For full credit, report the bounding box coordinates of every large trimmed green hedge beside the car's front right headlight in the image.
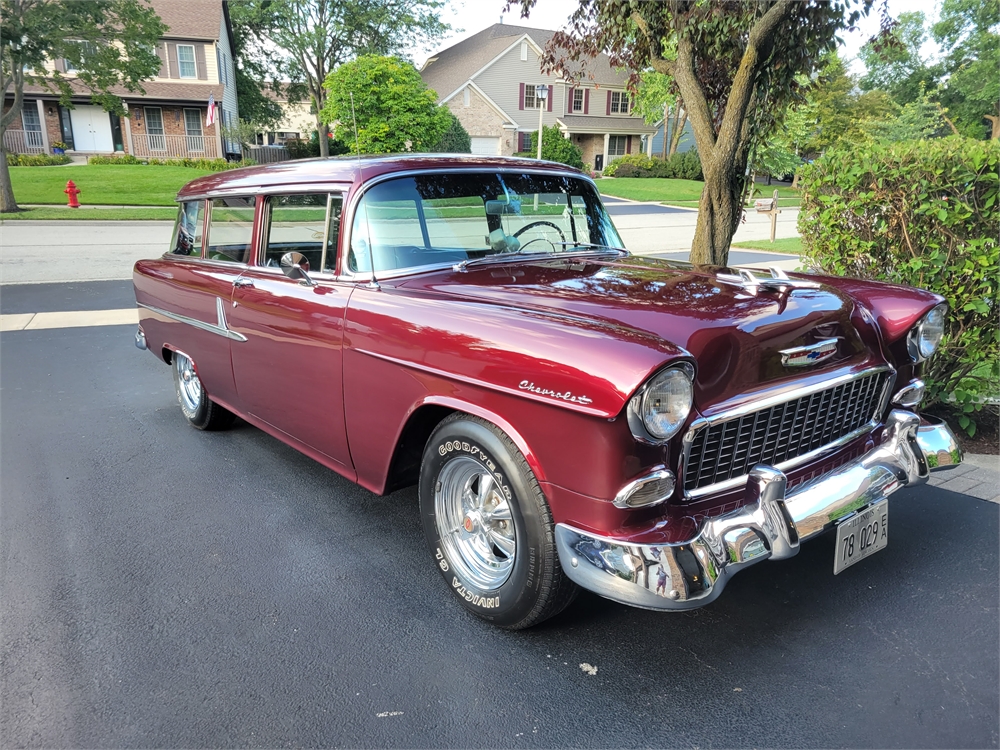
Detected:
[799,136,1000,435]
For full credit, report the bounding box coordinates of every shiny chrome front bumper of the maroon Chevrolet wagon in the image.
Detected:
[556,410,962,610]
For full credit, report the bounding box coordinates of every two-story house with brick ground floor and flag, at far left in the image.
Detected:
[4,0,240,159]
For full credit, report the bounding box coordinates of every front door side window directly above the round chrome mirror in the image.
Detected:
[263,193,344,273]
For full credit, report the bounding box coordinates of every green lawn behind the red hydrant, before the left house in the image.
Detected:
[10,164,211,207]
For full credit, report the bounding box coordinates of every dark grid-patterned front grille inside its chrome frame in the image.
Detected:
[684,371,891,492]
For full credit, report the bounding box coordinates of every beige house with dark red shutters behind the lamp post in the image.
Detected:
[420,23,655,170]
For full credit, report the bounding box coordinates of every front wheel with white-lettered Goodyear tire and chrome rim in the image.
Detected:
[420,414,577,630]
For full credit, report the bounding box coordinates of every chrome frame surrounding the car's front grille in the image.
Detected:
[677,365,896,500]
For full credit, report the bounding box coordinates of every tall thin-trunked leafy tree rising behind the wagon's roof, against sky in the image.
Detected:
[245,0,450,156]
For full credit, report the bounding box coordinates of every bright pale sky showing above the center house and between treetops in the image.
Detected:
[410,0,940,75]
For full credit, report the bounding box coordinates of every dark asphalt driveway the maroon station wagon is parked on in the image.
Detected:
[0,280,1000,748]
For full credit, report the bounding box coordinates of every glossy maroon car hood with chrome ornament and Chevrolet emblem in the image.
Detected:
[405,257,879,407]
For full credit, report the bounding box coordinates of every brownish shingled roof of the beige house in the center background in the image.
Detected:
[420,23,628,101]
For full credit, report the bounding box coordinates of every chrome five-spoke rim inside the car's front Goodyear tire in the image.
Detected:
[434,456,517,591]
